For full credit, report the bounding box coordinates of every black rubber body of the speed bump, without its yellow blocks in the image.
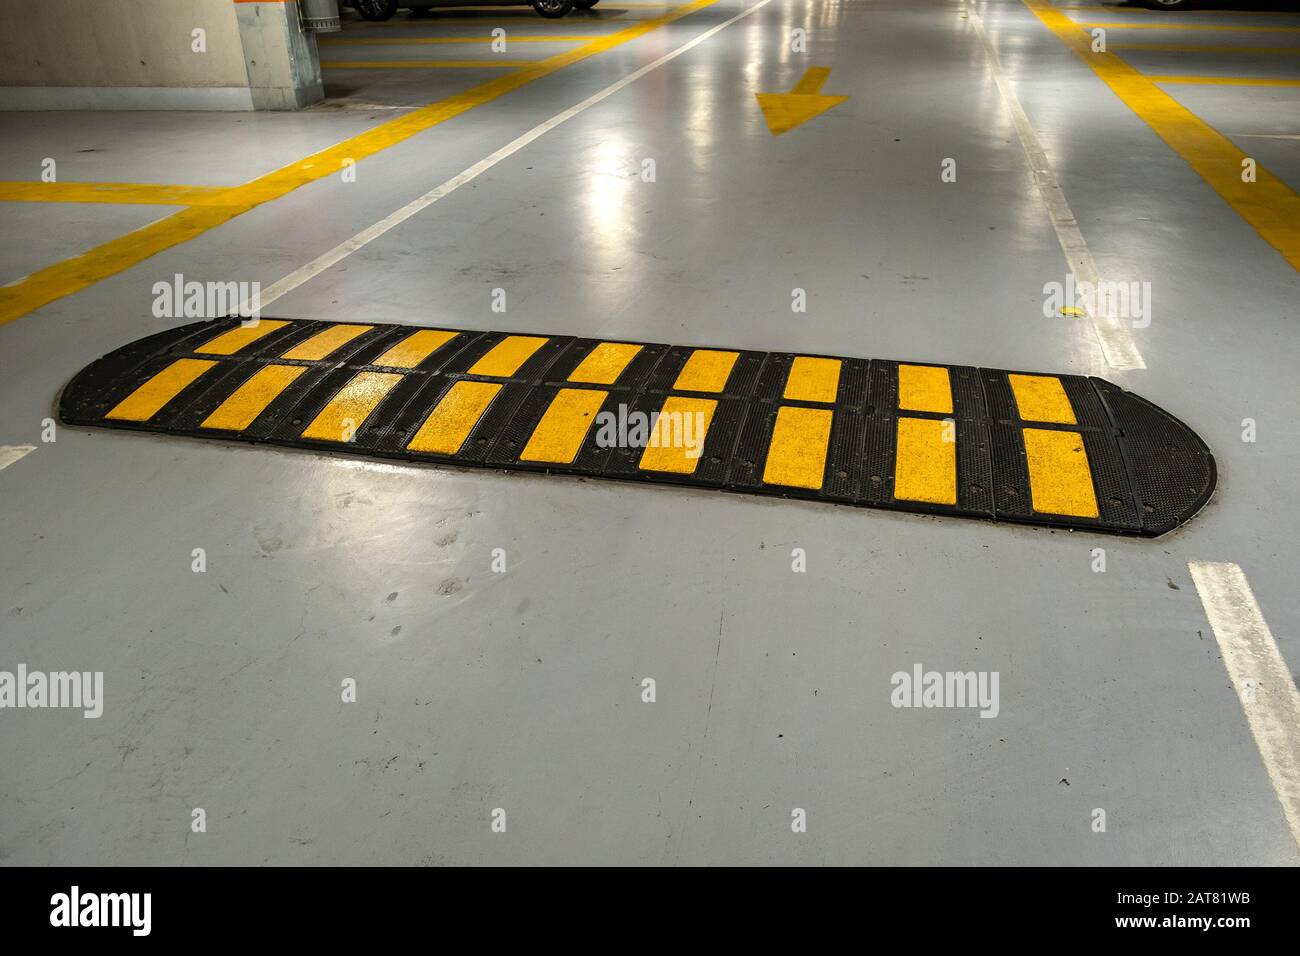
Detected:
[59,319,1216,537]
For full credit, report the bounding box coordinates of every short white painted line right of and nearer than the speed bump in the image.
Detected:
[1187,561,1300,848]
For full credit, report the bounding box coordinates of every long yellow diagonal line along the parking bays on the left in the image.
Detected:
[0,0,718,325]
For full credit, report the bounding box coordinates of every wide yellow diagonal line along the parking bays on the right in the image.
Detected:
[1023,0,1300,269]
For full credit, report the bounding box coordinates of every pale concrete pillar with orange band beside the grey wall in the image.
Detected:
[235,0,325,109]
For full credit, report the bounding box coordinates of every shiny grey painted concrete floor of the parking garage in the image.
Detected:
[0,0,1300,865]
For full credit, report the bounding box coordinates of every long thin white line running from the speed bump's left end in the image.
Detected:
[253,0,772,308]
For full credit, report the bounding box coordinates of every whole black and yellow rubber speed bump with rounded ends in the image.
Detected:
[60,319,1216,537]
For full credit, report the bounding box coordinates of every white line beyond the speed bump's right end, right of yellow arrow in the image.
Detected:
[962,7,1147,372]
